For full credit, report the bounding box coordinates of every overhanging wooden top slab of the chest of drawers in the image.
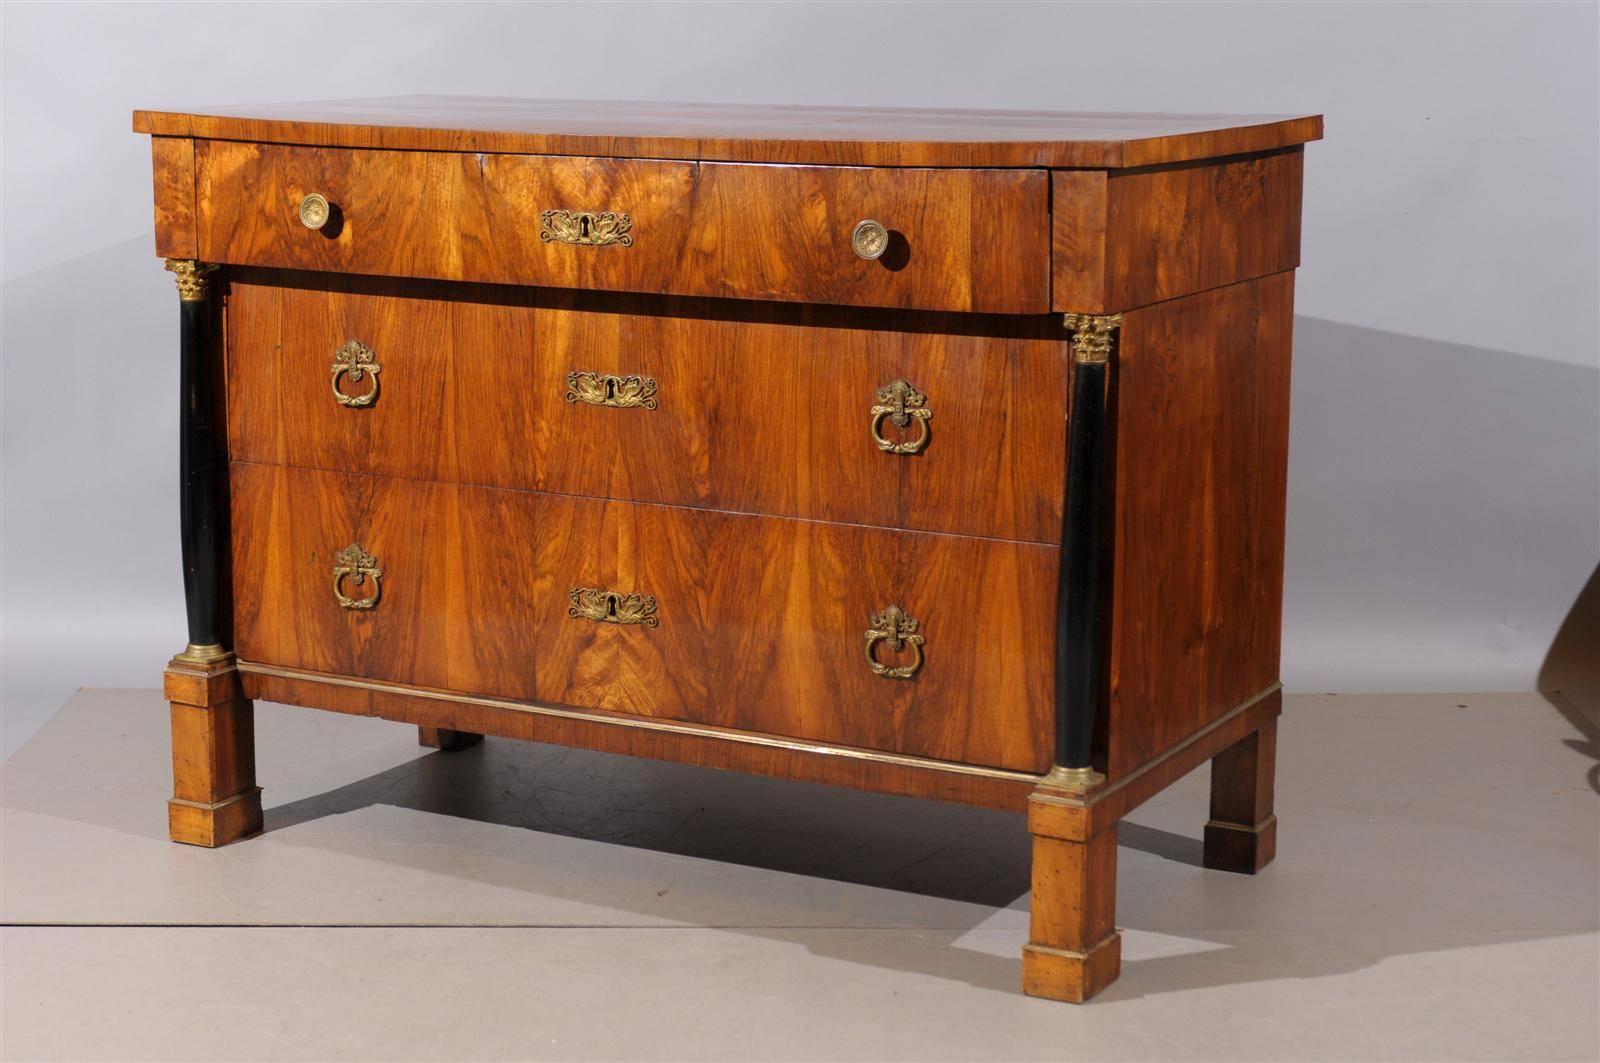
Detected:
[133,96,1322,168]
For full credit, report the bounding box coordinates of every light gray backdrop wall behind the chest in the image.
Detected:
[0,3,1600,752]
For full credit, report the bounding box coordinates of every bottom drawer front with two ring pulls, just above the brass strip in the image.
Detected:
[232,464,1056,772]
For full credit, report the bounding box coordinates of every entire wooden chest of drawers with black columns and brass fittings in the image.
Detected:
[134,98,1320,1001]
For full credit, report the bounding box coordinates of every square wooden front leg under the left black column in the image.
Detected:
[163,653,261,848]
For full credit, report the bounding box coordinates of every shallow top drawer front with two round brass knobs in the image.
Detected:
[195,141,1050,314]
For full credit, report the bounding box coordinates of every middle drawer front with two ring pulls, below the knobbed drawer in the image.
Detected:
[229,279,1067,543]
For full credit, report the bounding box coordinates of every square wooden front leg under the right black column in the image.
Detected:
[1022,789,1122,1004]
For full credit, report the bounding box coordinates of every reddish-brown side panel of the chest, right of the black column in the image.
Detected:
[1099,274,1294,780]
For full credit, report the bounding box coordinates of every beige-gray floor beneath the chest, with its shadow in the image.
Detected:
[0,690,1600,1061]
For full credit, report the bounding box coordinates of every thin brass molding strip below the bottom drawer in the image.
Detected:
[238,661,1043,786]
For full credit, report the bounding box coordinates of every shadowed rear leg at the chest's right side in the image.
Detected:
[1205,717,1278,874]
